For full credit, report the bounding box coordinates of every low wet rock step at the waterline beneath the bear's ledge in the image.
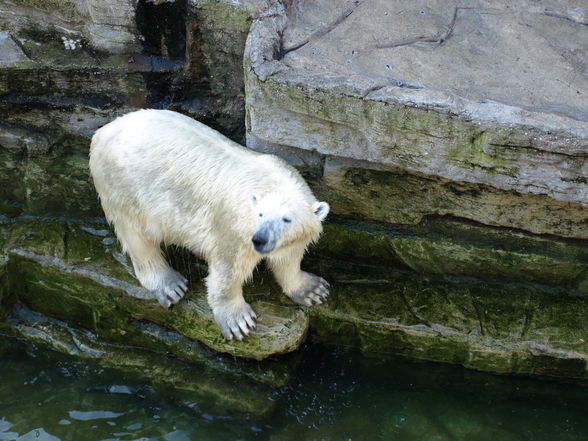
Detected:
[8,306,276,417]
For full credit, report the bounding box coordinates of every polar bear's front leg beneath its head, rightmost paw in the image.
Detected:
[268,247,329,306]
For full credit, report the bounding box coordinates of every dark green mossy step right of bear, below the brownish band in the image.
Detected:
[312,218,588,294]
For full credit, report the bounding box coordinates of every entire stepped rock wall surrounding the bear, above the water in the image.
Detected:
[0,0,588,374]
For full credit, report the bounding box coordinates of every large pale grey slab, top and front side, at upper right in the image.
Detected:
[245,0,588,206]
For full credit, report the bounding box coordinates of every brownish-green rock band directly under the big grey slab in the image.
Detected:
[313,162,588,239]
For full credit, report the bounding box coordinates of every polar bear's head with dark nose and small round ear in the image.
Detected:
[251,193,329,255]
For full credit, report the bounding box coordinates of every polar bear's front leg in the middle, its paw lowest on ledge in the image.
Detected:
[206,259,257,340]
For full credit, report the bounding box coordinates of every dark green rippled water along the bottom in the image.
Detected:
[0,338,588,441]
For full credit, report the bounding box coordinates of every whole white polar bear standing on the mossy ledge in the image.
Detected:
[90,110,329,340]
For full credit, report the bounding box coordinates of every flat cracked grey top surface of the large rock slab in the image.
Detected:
[282,0,588,122]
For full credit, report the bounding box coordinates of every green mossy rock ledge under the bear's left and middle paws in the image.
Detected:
[4,222,308,360]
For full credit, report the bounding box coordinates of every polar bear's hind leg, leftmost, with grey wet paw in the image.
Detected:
[114,221,187,308]
